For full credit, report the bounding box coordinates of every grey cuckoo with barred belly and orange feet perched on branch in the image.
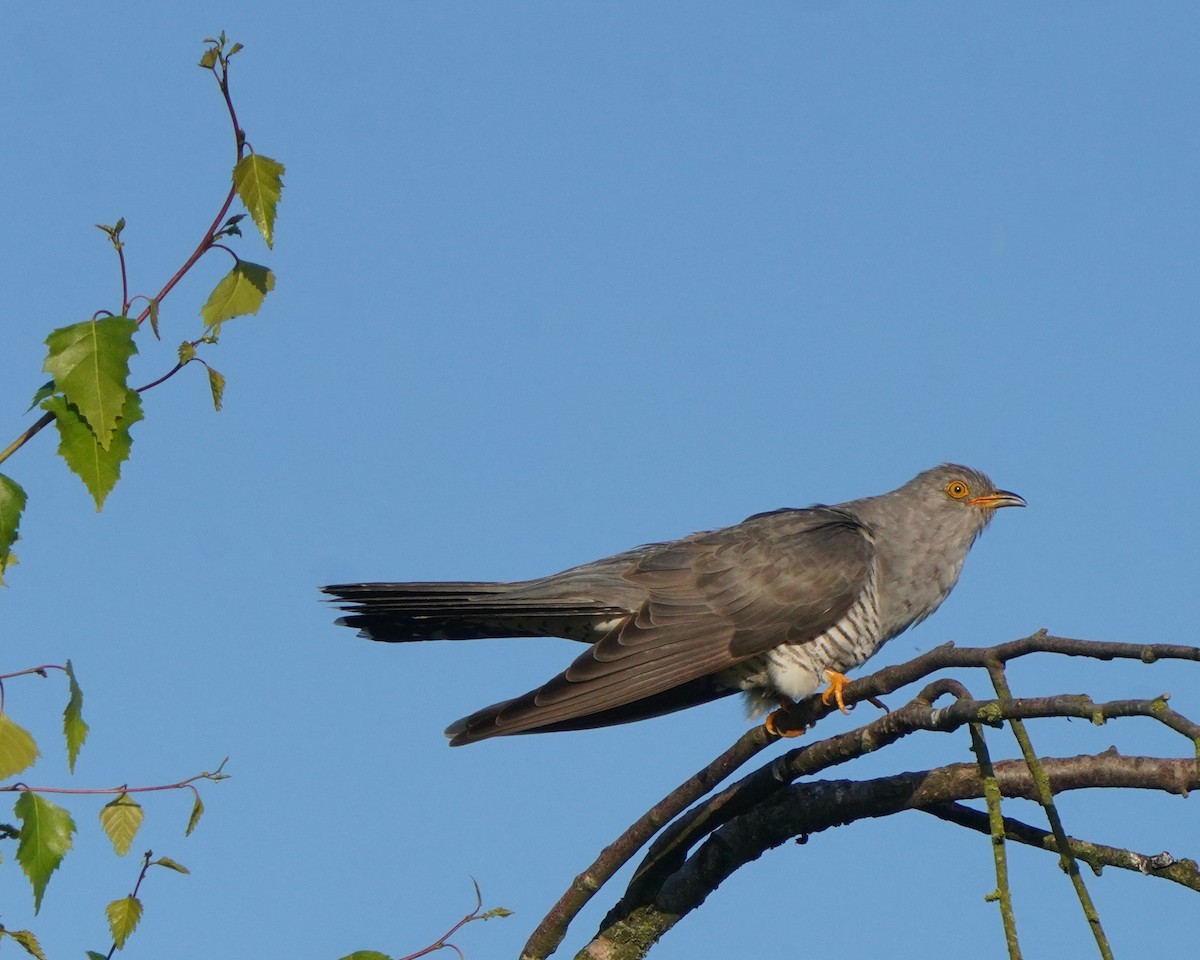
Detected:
[322,463,1026,746]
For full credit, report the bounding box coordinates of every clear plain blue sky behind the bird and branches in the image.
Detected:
[0,1,1200,959]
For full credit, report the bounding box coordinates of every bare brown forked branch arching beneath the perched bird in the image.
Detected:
[522,631,1200,960]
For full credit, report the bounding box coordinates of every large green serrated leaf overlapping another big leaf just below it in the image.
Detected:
[43,317,138,450]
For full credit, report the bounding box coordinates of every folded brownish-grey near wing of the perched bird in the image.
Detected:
[448,508,874,743]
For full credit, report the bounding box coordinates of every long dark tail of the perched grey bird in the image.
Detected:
[322,582,628,643]
